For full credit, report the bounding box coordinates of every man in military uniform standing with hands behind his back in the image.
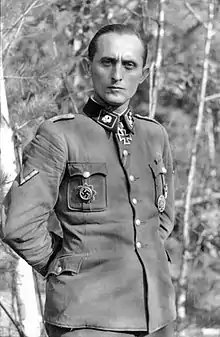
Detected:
[2,24,175,337]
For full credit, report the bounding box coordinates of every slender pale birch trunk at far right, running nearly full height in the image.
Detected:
[177,0,215,326]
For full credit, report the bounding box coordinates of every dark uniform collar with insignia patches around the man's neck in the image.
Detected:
[83,98,134,133]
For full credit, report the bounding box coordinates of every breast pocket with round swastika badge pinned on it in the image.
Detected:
[67,162,107,212]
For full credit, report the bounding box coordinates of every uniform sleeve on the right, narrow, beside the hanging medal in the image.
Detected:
[160,127,175,242]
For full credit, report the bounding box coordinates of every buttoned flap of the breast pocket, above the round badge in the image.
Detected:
[67,162,107,178]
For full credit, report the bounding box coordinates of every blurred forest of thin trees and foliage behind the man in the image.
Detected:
[0,0,220,337]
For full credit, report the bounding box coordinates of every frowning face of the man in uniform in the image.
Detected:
[90,33,145,110]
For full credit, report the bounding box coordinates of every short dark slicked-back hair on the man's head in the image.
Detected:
[88,23,148,65]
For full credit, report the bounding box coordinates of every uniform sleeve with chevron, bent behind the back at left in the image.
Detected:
[1,121,66,275]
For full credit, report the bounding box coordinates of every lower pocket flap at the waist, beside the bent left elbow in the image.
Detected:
[46,255,84,277]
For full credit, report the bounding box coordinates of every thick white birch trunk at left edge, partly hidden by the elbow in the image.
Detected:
[0,44,41,337]
